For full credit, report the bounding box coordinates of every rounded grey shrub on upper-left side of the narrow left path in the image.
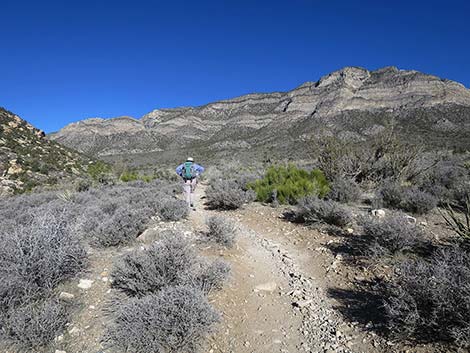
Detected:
[91,206,152,247]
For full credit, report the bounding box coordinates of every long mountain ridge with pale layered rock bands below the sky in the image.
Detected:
[51,67,470,163]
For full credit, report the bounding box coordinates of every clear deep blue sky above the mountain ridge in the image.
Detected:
[0,0,470,132]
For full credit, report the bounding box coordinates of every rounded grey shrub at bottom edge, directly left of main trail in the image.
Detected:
[105,286,219,353]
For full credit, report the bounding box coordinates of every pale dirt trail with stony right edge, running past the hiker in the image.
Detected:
[190,186,383,353]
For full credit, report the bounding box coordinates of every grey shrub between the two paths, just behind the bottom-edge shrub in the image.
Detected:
[112,233,197,296]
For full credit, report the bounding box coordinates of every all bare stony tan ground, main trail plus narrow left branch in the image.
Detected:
[35,185,454,353]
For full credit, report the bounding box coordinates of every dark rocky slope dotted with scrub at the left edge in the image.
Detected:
[0,108,89,195]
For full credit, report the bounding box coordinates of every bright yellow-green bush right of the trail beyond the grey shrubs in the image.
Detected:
[248,165,330,204]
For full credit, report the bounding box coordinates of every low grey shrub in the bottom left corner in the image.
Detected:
[0,298,69,351]
